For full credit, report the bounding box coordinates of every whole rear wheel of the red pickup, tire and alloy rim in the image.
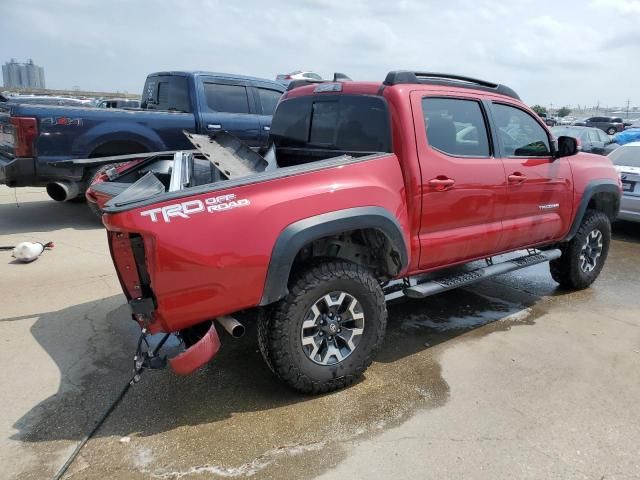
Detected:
[258,261,387,393]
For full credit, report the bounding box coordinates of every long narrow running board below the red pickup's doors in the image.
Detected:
[402,249,562,298]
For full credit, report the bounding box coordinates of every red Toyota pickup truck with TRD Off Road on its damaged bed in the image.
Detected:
[90,71,621,392]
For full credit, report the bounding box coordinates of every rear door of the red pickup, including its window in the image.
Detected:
[411,92,506,270]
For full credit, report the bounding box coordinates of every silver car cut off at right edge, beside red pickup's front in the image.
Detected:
[609,142,640,222]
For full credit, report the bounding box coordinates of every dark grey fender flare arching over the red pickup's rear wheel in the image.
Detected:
[260,207,409,305]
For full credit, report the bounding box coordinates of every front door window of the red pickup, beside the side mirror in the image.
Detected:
[493,103,551,157]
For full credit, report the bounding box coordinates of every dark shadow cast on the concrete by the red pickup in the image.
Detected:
[11,270,559,443]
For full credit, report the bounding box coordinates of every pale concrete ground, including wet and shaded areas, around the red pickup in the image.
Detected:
[0,187,640,479]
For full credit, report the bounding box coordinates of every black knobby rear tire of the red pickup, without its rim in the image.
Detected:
[258,260,387,393]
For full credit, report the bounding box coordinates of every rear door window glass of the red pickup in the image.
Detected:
[422,97,490,157]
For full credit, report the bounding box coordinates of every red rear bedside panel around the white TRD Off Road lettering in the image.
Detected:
[103,154,409,331]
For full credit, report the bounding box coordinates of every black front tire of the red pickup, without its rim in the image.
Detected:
[549,210,611,290]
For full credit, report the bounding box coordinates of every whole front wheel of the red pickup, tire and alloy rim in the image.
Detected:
[549,210,611,290]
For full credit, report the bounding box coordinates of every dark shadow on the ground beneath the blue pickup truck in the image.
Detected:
[0,195,103,234]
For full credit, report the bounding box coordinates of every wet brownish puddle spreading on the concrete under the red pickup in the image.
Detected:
[15,280,538,479]
